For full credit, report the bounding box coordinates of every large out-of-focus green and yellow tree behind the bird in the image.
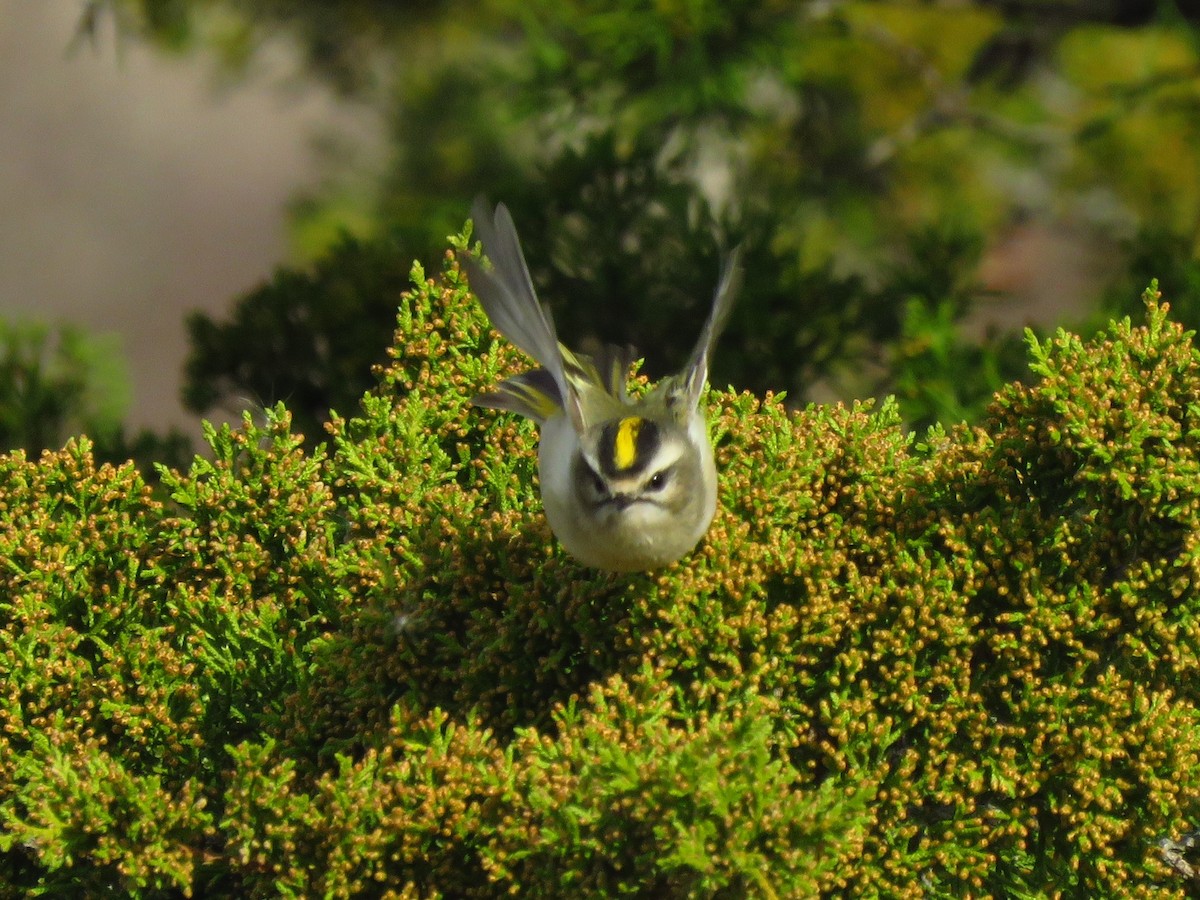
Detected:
[84,0,1200,439]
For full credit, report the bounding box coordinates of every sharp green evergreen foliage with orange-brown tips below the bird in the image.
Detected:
[0,239,1200,898]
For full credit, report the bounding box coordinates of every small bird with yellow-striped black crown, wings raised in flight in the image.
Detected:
[462,199,740,571]
